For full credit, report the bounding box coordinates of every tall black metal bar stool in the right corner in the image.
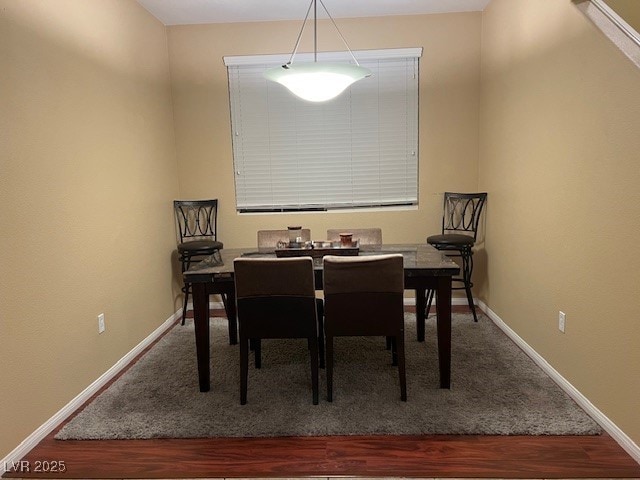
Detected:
[425,192,487,322]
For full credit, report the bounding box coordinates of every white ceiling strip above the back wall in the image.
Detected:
[137,0,491,25]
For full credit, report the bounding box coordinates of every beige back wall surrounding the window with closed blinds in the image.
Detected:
[168,12,481,247]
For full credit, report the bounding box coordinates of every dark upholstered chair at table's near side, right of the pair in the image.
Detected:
[324,254,407,402]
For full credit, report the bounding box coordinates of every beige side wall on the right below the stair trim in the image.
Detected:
[479,0,640,443]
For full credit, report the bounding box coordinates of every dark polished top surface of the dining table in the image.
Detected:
[184,243,460,282]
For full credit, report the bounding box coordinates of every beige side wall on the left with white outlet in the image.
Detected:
[0,0,178,457]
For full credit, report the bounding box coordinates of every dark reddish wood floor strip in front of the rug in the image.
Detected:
[3,308,640,479]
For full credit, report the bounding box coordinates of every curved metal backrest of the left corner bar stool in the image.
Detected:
[173,199,218,243]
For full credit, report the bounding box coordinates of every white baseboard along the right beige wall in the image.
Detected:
[478,302,640,463]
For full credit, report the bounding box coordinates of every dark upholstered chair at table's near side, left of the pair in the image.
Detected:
[233,257,322,405]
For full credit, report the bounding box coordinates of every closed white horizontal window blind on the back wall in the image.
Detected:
[225,49,422,212]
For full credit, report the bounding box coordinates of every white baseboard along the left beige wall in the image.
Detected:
[0,309,182,468]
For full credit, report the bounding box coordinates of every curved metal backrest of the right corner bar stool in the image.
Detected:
[442,192,487,241]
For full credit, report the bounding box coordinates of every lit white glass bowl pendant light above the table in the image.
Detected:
[264,0,371,102]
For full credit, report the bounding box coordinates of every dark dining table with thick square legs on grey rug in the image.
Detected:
[183,244,460,392]
